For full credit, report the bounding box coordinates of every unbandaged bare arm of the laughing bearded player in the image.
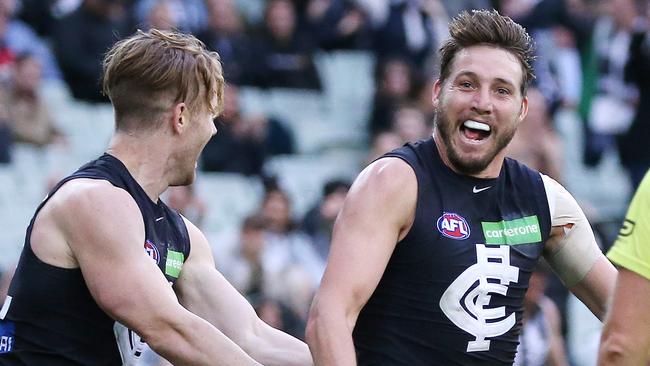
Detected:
[307,158,417,366]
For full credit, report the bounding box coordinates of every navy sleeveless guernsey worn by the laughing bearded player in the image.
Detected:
[353,138,551,366]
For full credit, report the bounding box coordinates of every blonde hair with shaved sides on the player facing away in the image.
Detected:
[103,29,225,130]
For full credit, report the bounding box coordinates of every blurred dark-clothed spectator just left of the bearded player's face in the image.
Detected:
[368,57,414,136]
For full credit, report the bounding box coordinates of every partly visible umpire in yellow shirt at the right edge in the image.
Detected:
[598,172,650,366]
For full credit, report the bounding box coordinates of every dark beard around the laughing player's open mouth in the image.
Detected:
[434,110,516,175]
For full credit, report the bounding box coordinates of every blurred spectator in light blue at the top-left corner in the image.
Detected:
[0,0,61,79]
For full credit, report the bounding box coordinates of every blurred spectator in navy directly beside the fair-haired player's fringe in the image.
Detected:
[199,0,258,85]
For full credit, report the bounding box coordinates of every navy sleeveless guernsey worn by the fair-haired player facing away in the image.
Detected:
[0,154,190,366]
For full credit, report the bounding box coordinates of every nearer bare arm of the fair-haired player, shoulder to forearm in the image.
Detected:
[53,180,258,365]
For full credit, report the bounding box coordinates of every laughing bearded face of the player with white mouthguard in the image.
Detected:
[433,45,528,178]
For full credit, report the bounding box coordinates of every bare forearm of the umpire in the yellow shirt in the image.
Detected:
[598,268,650,366]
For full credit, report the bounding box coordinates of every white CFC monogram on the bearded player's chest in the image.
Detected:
[440,244,519,352]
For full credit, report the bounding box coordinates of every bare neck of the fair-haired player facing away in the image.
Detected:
[106,132,170,202]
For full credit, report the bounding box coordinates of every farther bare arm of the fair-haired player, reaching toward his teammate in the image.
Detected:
[175,220,313,366]
